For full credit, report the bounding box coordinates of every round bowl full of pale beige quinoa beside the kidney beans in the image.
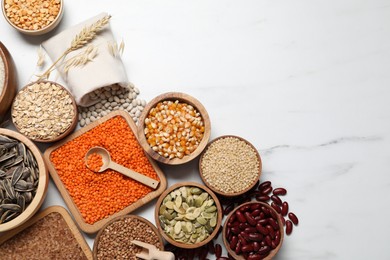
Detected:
[199,135,262,197]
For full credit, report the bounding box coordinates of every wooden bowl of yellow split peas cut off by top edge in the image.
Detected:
[2,0,64,35]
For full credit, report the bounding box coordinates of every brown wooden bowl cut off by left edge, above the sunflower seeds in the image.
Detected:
[0,42,17,121]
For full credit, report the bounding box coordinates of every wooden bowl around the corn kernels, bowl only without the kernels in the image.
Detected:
[138,92,211,165]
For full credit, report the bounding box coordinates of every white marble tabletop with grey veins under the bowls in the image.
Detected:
[0,0,390,260]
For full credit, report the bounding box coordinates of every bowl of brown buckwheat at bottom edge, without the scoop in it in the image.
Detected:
[93,215,164,260]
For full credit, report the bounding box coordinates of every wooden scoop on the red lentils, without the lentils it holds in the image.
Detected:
[85,146,159,189]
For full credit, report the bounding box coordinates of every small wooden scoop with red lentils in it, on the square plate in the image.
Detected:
[85,146,159,189]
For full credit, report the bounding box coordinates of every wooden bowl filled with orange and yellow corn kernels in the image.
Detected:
[138,92,211,165]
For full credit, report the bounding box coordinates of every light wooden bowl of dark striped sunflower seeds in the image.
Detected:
[0,128,49,232]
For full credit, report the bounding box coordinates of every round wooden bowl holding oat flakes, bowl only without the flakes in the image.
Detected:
[11,80,78,143]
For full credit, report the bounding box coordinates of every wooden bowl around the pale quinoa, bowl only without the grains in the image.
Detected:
[199,135,262,197]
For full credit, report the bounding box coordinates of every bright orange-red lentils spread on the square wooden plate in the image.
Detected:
[50,116,158,224]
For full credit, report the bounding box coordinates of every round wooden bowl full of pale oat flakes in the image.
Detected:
[11,81,77,142]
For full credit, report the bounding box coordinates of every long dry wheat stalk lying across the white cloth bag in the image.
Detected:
[39,15,111,80]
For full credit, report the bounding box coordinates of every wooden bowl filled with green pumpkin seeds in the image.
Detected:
[155,182,222,248]
